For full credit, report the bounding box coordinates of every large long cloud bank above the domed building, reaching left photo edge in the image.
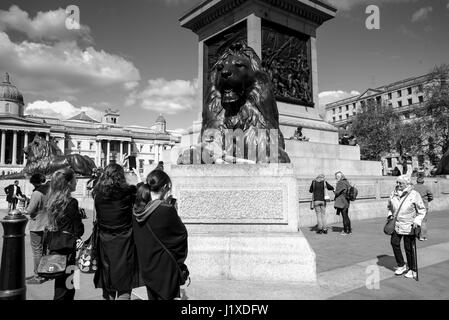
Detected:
[0,32,140,99]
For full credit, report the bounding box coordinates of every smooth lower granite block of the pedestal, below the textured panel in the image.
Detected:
[186,230,316,282]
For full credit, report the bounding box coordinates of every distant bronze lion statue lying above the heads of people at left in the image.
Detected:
[23,136,96,176]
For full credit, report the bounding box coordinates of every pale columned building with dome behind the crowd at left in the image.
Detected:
[0,73,180,175]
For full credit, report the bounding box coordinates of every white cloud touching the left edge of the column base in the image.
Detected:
[126,78,199,114]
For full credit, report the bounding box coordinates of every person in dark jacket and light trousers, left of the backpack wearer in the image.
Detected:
[309,174,334,234]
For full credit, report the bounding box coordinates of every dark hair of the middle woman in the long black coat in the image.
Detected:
[92,163,128,199]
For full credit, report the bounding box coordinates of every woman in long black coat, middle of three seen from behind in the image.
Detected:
[93,163,139,300]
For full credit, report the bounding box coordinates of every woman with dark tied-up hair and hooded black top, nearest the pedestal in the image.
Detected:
[133,170,188,300]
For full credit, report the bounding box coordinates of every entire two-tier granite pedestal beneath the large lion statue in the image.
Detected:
[170,164,316,281]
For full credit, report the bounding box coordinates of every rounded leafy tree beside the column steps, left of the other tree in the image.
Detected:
[351,101,400,160]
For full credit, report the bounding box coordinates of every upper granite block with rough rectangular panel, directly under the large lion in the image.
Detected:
[170,164,299,232]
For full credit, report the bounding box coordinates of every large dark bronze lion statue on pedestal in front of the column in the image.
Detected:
[178,41,290,164]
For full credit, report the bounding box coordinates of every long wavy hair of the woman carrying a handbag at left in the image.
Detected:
[46,168,75,227]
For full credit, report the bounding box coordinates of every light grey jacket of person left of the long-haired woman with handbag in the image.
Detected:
[26,182,50,232]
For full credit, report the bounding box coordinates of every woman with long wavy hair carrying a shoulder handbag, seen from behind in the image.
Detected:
[46,168,84,300]
